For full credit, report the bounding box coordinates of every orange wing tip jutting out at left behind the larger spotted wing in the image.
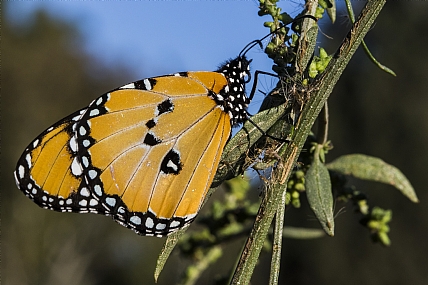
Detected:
[14,109,108,214]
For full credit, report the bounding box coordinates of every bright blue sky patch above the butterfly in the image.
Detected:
[5,0,303,111]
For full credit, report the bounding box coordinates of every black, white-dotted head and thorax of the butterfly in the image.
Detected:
[214,55,251,125]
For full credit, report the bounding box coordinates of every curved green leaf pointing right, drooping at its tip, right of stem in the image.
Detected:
[327,154,419,203]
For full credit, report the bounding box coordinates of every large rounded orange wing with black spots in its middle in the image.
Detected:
[75,72,231,236]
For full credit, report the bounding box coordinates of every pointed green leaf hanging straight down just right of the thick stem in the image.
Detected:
[305,145,334,236]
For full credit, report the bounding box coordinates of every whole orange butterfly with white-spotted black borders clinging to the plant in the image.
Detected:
[14,16,314,236]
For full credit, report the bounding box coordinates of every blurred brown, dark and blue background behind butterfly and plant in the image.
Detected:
[0,0,428,285]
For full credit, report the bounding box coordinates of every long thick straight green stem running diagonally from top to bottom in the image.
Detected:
[231,0,386,285]
